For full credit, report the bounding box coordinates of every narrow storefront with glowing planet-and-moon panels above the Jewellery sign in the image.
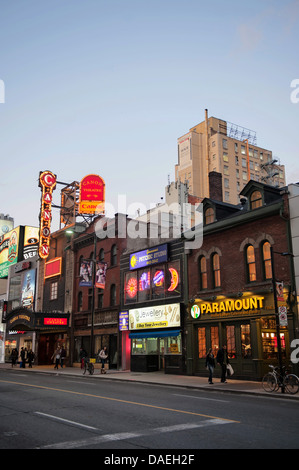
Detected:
[119,240,185,374]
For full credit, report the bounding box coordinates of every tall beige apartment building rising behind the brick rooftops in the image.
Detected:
[175,110,286,204]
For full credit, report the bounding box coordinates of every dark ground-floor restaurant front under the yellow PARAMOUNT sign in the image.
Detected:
[187,292,293,380]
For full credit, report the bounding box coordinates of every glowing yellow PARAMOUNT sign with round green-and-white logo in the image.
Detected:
[190,297,264,318]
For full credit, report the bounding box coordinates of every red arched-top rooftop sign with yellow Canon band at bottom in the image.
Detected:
[79,175,105,215]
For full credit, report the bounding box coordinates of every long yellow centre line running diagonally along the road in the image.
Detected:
[0,380,240,423]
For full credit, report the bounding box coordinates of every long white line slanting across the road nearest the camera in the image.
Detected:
[39,418,232,449]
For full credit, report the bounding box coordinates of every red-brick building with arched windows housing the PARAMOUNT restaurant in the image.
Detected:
[186,175,296,379]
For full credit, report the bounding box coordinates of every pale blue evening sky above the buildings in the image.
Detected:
[0,0,299,230]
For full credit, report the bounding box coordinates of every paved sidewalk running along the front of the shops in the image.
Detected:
[0,364,299,400]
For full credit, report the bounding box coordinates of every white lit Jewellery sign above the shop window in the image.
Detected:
[129,304,181,330]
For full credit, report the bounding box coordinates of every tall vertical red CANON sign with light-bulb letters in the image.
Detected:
[39,171,56,259]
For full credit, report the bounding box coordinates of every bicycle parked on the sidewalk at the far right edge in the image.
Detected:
[262,365,299,395]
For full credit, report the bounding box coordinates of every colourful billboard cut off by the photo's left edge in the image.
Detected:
[0,227,20,278]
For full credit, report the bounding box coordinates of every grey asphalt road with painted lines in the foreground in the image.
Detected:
[0,370,299,454]
